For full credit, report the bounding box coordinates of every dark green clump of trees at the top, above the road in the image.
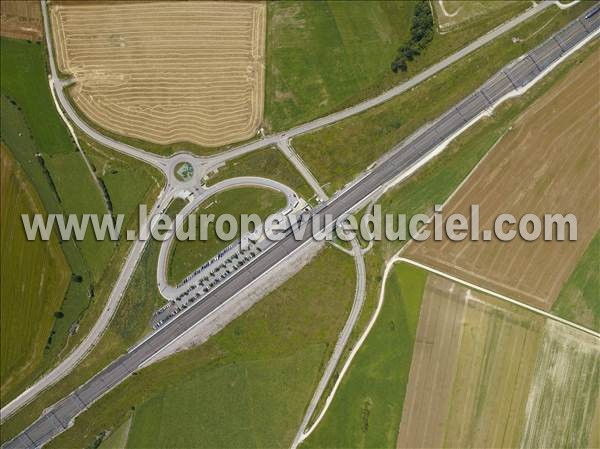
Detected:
[392,0,433,73]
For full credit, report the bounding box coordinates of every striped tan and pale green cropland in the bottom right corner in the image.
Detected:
[398,275,600,448]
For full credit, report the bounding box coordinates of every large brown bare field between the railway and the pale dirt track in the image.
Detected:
[407,48,600,309]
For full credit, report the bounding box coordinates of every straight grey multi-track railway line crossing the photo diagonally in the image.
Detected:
[3,4,600,448]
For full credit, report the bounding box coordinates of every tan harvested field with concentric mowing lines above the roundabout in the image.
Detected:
[51,1,266,147]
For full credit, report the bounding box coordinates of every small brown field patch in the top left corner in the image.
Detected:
[0,0,42,41]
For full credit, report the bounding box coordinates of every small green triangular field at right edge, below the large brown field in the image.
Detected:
[552,232,600,331]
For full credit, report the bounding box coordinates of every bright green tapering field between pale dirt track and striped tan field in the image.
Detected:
[303,264,427,448]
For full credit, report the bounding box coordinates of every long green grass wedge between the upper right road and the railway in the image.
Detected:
[293,5,586,193]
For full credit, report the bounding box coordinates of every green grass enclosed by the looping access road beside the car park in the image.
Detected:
[168,188,286,283]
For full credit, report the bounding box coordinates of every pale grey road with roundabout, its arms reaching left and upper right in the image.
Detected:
[0,0,553,422]
